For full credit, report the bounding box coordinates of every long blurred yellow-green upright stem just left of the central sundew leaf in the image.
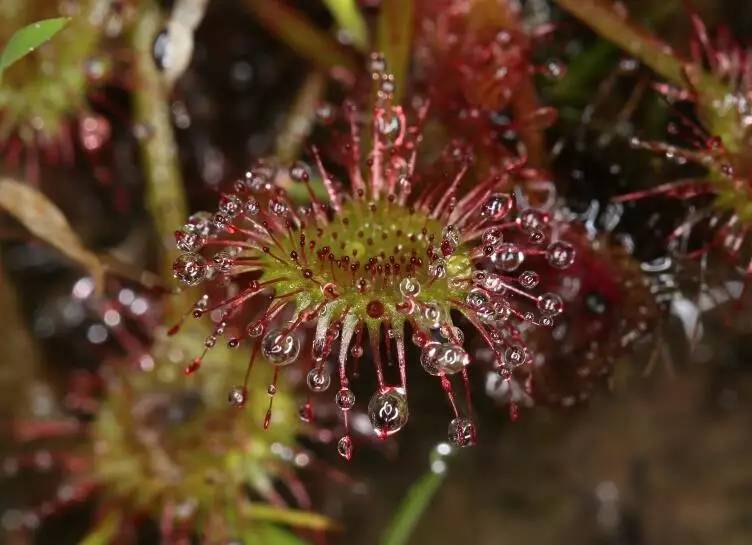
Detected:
[132,4,187,284]
